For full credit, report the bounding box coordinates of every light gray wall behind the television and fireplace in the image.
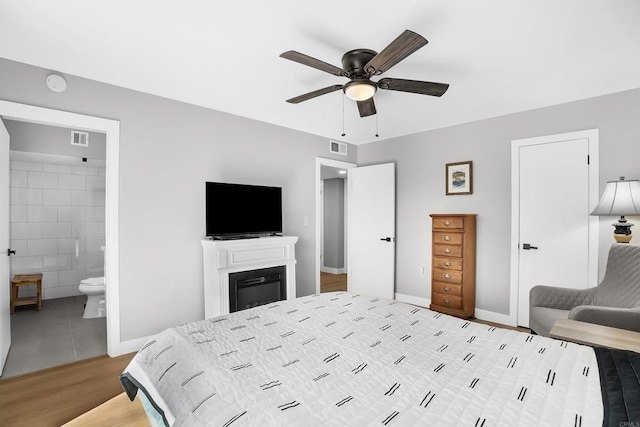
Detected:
[0,59,357,341]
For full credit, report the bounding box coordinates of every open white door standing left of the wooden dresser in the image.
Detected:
[347,163,396,299]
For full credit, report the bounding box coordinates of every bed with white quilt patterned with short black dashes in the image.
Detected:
[121,292,640,427]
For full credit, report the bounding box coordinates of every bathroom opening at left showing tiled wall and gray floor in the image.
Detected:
[2,119,106,378]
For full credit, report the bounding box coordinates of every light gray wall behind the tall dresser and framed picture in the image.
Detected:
[358,89,640,314]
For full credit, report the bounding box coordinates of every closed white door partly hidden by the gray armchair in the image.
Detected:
[513,134,597,327]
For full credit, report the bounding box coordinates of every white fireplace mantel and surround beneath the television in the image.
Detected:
[201,236,298,319]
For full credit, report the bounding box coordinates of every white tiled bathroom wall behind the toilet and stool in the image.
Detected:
[9,151,105,299]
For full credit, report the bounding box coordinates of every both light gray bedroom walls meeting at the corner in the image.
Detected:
[5,55,640,332]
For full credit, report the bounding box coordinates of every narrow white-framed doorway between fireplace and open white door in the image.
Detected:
[315,157,357,293]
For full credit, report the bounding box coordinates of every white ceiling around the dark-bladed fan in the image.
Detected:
[0,0,640,144]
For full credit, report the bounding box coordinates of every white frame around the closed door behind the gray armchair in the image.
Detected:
[509,129,600,326]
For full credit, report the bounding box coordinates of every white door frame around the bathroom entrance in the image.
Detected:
[0,100,122,357]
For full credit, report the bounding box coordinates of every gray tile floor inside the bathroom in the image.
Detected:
[0,295,107,378]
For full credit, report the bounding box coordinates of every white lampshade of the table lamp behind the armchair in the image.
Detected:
[591,177,640,216]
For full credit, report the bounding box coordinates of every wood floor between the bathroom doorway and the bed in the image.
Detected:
[0,353,133,427]
